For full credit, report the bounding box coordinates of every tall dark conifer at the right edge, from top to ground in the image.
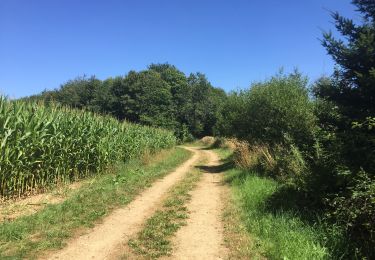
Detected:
[313,0,375,259]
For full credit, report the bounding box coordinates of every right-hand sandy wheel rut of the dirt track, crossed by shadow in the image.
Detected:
[170,151,227,260]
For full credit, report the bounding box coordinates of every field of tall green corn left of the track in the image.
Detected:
[0,97,176,197]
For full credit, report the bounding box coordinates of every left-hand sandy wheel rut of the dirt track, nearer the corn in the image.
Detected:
[48,148,202,259]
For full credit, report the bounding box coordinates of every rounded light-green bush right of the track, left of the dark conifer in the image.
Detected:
[215,73,317,151]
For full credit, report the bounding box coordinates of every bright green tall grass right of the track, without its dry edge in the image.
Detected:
[228,172,330,259]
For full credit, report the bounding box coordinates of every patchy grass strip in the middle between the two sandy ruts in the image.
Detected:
[123,155,206,259]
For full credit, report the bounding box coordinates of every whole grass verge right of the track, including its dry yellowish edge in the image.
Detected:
[215,149,335,259]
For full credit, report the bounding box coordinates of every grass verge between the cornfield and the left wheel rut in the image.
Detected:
[0,148,191,259]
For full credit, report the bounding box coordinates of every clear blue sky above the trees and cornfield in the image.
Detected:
[0,0,359,98]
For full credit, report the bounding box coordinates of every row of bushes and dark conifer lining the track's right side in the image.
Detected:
[216,0,375,259]
